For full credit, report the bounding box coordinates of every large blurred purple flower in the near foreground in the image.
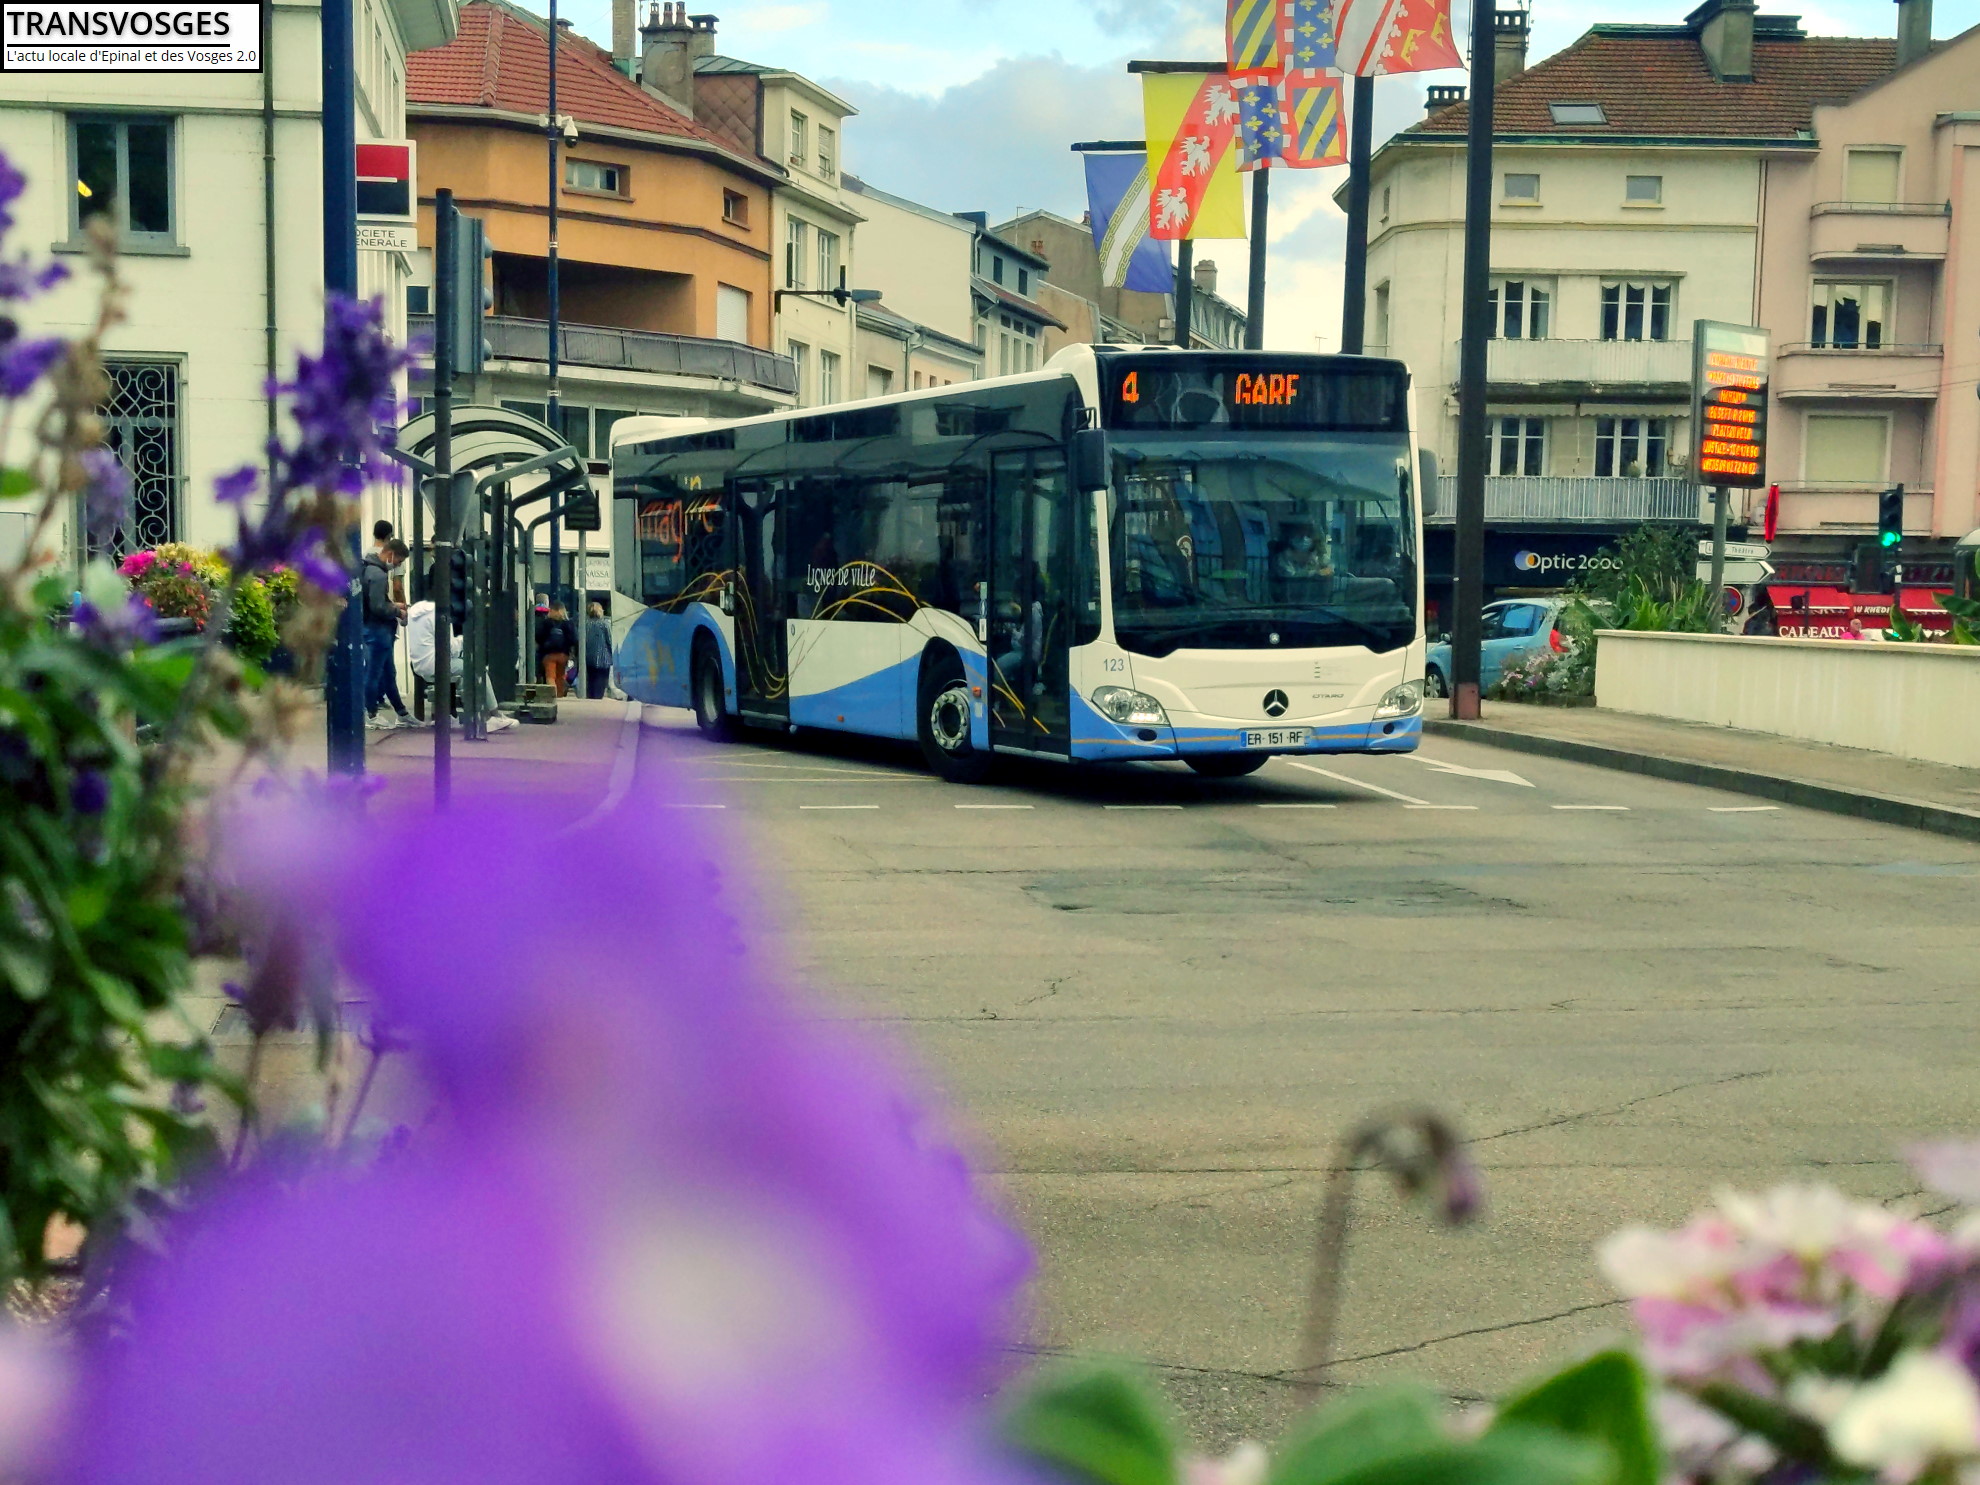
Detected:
[67,768,1026,1485]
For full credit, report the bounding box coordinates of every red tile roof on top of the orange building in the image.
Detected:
[406,0,729,149]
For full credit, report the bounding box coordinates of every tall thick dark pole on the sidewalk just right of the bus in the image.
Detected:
[1451,0,1497,719]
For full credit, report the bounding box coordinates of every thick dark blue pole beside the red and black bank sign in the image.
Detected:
[321,0,366,774]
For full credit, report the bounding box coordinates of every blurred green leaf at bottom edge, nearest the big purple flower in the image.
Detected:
[1002,1366,1176,1485]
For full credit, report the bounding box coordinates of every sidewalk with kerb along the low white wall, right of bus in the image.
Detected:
[1424,701,1980,840]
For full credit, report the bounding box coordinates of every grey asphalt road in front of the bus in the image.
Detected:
[640,709,1980,1443]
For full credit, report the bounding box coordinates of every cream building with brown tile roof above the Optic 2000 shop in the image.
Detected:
[1366,0,1972,605]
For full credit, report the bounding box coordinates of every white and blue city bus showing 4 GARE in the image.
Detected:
[612,347,1424,782]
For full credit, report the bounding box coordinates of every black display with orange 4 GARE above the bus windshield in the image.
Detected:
[1101,356,1408,432]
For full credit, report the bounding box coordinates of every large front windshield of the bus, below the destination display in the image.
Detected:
[1109,430,1416,655]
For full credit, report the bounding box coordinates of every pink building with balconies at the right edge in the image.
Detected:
[1752,0,1980,562]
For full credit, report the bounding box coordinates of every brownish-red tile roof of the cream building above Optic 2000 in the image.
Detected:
[1408,26,1897,139]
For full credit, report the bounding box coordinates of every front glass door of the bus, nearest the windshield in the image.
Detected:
[986,449,1073,752]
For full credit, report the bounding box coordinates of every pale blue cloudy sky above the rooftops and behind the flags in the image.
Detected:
[539,0,1948,350]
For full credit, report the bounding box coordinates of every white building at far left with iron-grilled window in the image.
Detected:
[0,0,455,562]
